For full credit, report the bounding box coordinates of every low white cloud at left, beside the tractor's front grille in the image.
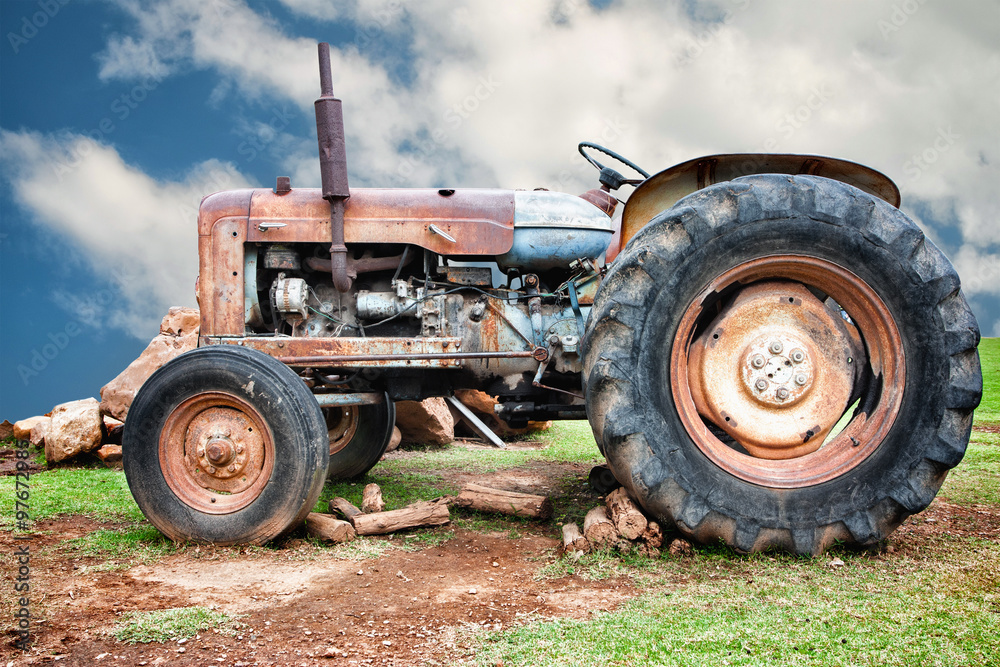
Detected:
[0,130,246,339]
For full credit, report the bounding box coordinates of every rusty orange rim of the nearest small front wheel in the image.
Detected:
[159,392,275,514]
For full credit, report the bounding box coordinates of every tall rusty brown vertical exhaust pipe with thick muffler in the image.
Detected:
[316,42,351,292]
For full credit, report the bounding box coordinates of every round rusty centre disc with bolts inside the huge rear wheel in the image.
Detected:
[690,280,857,459]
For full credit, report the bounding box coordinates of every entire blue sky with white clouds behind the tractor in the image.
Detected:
[0,0,1000,420]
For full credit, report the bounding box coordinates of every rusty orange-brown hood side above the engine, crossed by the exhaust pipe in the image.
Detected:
[248,188,514,255]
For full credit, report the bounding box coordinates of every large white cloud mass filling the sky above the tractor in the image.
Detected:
[76,0,1000,324]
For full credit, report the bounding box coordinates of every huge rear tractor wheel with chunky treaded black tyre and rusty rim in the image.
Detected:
[584,175,982,554]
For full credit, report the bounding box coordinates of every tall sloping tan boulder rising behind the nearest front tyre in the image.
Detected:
[101,307,198,421]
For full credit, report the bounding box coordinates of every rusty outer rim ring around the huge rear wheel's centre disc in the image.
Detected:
[670,255,905,488]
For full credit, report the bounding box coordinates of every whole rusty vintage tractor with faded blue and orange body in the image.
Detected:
[124,44,982,553]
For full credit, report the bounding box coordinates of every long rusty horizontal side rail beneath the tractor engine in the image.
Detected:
[201,336,533,368]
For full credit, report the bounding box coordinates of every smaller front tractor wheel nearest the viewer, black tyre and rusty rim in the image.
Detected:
[122,346,329,544]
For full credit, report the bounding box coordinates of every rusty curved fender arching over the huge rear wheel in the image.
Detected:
[620,153,900,247]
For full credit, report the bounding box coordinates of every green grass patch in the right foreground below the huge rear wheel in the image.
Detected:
[474,543,1000,667]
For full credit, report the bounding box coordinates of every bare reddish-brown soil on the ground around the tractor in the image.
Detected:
[0,440,1000,667]
